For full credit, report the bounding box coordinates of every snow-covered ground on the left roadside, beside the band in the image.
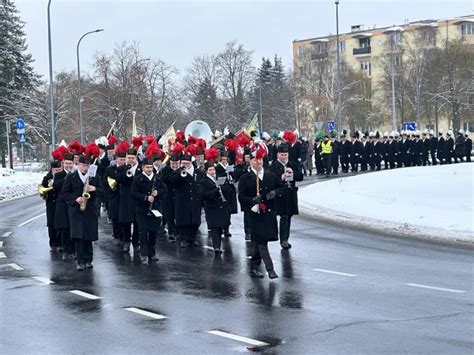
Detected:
[0,163,46,202]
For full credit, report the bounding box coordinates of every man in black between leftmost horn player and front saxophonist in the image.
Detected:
[54,153,74,260]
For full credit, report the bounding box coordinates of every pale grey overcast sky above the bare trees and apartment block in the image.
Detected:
[15,0,474,77]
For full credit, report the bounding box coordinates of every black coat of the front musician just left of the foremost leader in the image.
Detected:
[199,176,230,229]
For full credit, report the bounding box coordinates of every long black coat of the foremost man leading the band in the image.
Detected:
[239,170,284,243]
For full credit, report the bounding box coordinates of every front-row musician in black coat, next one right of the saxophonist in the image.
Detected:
[131,157,167,264]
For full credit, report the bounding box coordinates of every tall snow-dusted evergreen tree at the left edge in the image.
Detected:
[0,0,39,166]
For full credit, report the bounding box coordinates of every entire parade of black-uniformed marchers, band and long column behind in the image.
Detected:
[38,121,472,279]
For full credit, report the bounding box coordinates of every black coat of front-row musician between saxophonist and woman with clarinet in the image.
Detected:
[132,173,167,232]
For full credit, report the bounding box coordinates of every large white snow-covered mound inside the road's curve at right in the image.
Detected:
[299,163,474,243]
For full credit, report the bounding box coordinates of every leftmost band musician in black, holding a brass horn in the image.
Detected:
[41,158,66,253]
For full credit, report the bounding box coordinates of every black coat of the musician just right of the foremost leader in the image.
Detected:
[269,160,303,216]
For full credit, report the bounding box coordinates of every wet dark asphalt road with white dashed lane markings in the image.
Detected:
[0,182,474,354]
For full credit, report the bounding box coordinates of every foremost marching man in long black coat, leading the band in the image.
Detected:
[239,143,283,279]
